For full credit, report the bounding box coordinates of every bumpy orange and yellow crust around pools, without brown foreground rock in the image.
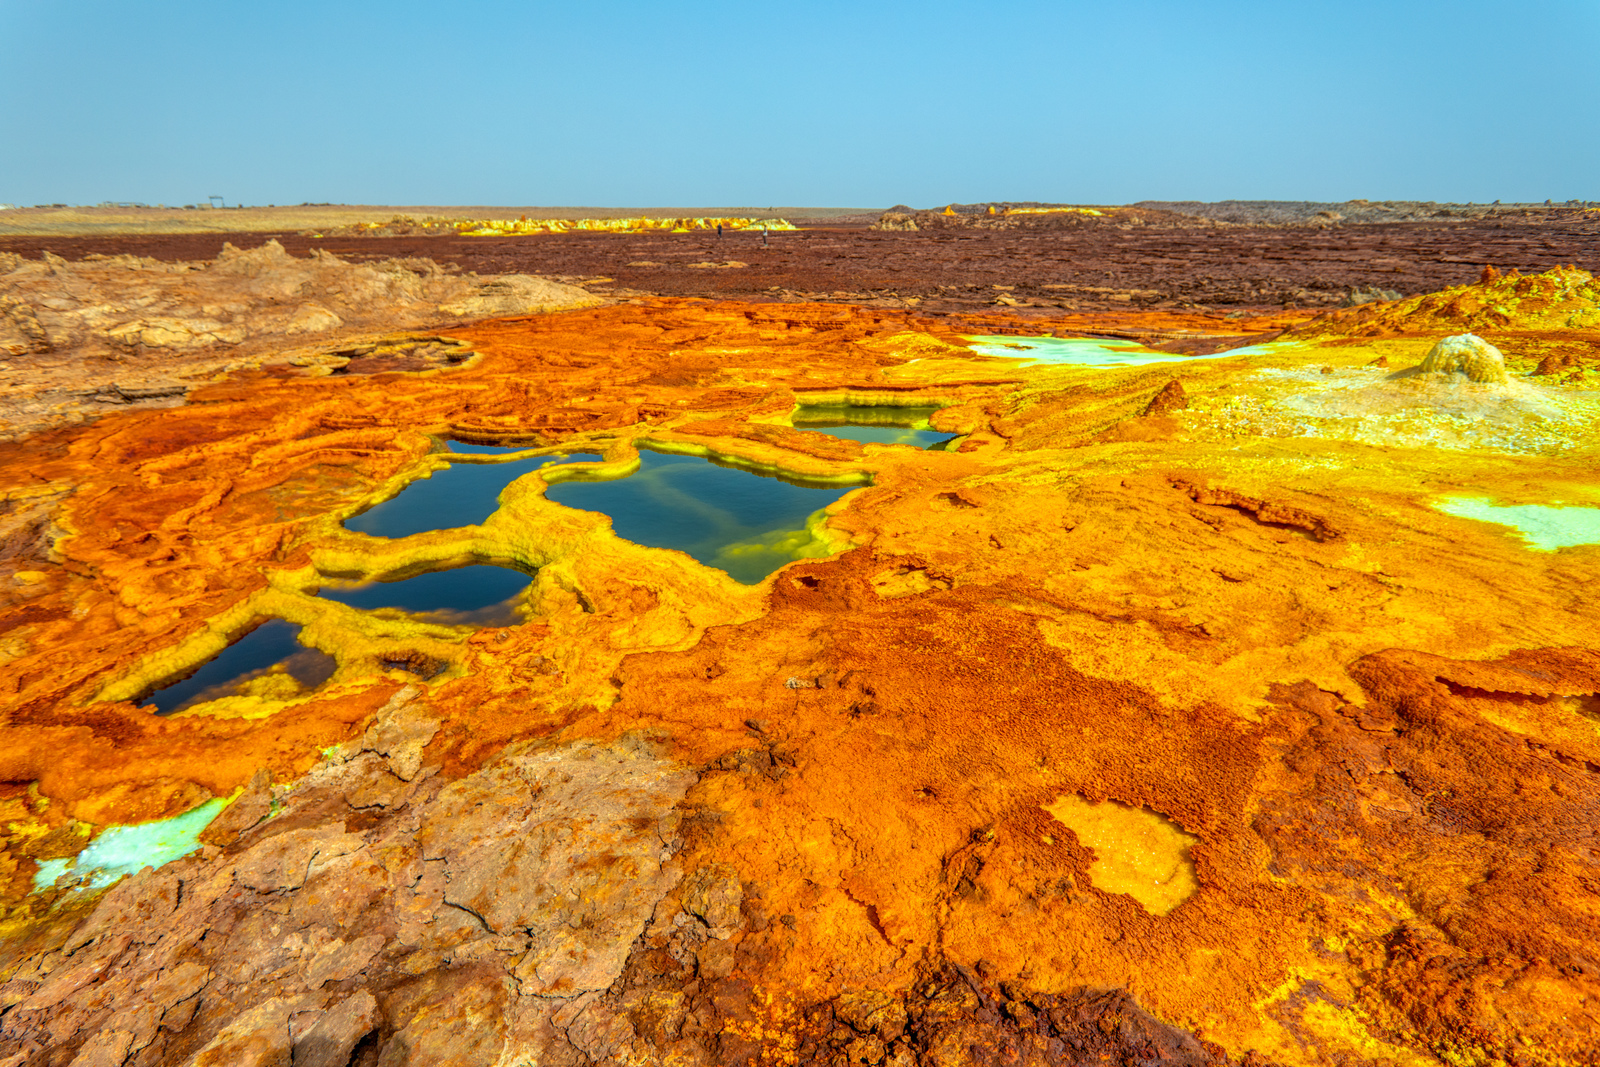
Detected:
[0,280,1600,1064]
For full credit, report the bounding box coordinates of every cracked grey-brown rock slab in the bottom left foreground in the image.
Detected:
[0,700,700,1067]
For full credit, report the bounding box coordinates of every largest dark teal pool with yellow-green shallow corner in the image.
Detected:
[544,450,856,585]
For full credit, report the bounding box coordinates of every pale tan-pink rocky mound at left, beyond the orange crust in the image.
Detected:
[0,240,602,435]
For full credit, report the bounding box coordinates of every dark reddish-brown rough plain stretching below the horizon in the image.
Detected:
[0,211,1600,314]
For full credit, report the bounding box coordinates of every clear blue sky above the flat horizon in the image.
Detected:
[0,0,1600,208]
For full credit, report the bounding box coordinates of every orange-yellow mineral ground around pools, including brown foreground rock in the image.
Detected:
[0,289,1600,1067]
